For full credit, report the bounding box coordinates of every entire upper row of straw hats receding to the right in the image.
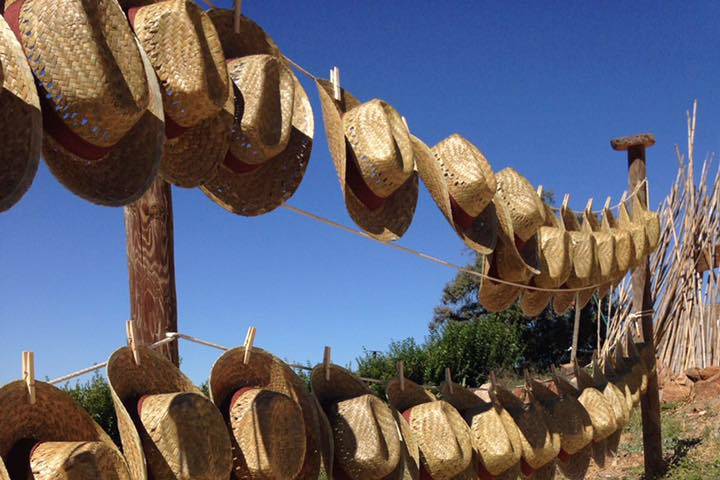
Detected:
[0,0,659,300]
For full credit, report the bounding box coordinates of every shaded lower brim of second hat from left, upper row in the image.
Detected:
[43,38,165,206]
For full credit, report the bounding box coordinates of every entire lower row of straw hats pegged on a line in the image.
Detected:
[0,335,651,480]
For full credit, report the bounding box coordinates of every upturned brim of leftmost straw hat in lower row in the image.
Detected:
[0,380,125,479]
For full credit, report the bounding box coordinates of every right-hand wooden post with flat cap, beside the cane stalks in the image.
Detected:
[610,134,665,479]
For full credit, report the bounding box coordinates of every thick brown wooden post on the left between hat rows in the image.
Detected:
[125,176,179,365]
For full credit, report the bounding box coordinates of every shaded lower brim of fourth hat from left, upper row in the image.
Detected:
[201,69,315,216]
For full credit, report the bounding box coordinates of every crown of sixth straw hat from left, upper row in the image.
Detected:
[432,134,497,217]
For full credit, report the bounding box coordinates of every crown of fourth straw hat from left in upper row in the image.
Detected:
[228,55,295,165]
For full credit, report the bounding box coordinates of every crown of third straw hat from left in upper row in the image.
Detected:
[134,0,229,127]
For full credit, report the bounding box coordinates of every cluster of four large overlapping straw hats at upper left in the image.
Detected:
[0,0,314,215]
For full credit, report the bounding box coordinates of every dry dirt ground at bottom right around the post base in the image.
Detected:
[586,398,720,480]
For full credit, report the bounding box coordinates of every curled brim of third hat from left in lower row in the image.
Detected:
[209,347,328,479]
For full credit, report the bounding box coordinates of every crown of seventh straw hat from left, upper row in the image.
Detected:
[495,168,545,241]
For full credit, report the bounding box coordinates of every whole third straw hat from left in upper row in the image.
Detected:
[120,0,233,188]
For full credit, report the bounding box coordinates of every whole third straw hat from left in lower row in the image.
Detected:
[210,348,324,479]
